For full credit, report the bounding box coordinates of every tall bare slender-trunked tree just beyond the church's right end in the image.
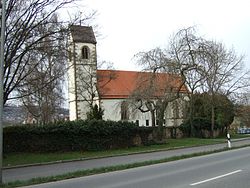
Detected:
[168,27,203,136]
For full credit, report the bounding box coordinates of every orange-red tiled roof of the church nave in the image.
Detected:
[97,70,187,99]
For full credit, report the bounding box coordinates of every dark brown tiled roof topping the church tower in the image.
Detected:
[70,25,96,44]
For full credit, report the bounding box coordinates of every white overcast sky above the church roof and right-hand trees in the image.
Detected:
[82,0,250,70]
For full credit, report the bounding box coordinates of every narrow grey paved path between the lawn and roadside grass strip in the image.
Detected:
[3,138,250,183]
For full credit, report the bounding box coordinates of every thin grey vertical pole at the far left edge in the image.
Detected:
[0,0,6,184]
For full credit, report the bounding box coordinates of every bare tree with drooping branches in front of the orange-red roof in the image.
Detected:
[131,48,185,139]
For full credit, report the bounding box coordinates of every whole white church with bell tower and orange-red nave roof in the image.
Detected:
[68,25,187,126]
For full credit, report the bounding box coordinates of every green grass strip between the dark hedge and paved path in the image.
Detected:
[3,138,226,167]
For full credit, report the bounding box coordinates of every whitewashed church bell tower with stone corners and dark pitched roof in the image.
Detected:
[68,25,98,120]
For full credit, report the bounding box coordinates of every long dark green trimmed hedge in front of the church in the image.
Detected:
[4,120,152,153]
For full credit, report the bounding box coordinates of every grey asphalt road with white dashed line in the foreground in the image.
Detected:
[22,147,250,188]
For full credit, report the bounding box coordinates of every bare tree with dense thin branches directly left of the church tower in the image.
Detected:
[17,16,66,124]
